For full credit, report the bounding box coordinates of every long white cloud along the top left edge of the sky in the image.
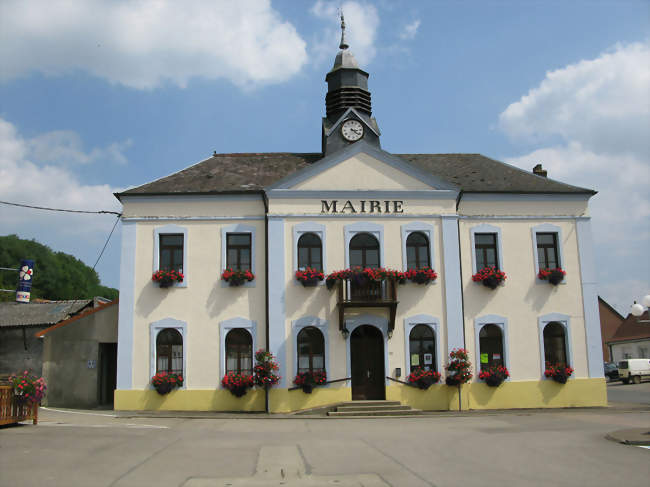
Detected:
[0,0,307,89]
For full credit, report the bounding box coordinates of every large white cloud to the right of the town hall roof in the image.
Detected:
[500,42,650,307]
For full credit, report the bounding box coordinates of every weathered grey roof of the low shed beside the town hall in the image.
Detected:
[0,299,93,328]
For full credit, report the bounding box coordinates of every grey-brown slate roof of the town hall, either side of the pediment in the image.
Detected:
[115,152,595,198]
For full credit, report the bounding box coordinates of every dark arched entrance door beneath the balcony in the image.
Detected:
[350,325,386,400]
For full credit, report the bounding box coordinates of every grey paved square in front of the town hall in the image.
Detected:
[0,408,650,487]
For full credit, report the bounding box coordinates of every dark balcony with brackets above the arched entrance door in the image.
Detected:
[336,278,399,337]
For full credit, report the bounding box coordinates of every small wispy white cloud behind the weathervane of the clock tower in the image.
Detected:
[311,0,379,68]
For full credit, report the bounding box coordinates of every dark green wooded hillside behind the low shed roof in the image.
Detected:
[0,235,118,301]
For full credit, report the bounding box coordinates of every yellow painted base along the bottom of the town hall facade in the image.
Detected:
[115,379,607,413]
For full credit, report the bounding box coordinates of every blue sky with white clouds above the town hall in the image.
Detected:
[0,0,650,311]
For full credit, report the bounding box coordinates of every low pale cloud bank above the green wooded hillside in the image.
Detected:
[0,118,121,286]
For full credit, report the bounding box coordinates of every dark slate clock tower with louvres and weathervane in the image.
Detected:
[322,14,380,156]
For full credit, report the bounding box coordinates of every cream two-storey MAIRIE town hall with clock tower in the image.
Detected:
[115,21,607,412]
